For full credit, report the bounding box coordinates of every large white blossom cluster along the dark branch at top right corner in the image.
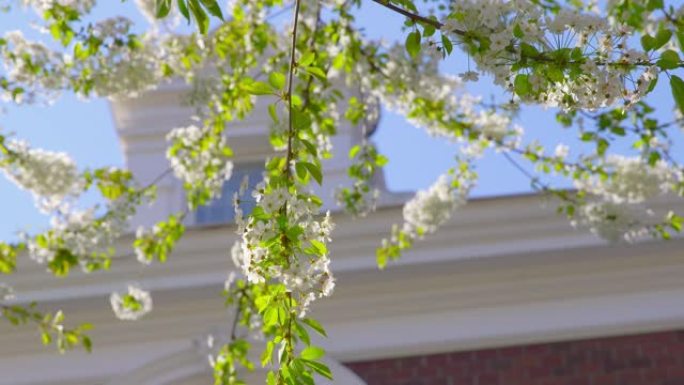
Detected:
[442,0,659,109]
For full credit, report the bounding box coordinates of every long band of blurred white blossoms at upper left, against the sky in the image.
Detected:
[0,16,201,103]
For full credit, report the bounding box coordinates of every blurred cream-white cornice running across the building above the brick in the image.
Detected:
[0,195,684,385]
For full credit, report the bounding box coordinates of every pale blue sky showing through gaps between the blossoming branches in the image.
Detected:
[0,1,672,239]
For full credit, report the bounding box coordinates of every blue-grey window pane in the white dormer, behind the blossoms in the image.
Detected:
[195,164,264,225]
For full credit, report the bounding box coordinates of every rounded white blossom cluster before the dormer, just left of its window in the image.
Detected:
[166,125,233,206]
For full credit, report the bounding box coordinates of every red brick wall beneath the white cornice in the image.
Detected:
[347,331,684,385]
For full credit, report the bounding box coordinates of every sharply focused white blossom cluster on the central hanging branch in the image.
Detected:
[232,182,335,317]
